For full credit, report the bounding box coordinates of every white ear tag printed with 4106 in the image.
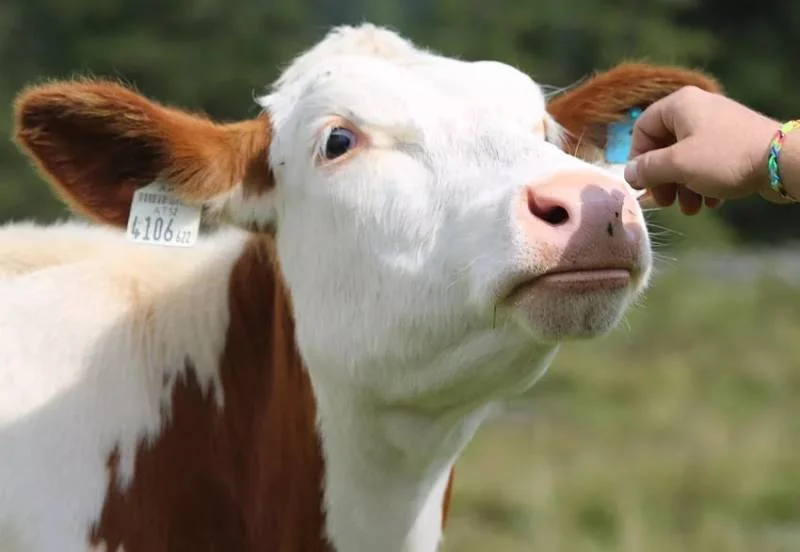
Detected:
[126,182,202,247]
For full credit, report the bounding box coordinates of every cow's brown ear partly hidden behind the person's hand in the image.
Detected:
[547,63,722,159]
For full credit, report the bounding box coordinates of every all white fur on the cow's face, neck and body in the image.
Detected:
[0,22,650,552]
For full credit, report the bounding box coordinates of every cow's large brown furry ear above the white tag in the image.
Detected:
[15,80,273,226]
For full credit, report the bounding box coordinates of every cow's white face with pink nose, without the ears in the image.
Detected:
[260,43,651,384]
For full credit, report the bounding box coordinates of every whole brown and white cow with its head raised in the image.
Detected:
[0,24,718,552]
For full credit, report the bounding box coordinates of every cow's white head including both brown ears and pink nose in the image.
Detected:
[17,26,714,408]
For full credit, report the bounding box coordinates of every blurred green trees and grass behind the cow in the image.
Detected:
[0,0,800,552]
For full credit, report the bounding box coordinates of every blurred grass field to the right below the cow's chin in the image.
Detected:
[445,249,800,552]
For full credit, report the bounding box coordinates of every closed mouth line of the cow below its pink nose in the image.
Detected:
[503,266,634,302]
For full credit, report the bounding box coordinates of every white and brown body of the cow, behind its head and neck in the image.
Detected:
[0,225,456,552]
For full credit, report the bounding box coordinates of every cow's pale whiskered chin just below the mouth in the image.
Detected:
[508,277,635,342]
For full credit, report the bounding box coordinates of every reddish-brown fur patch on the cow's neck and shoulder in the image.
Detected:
[91,237,332,552]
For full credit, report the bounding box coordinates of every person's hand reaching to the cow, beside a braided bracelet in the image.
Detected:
[625,86,783,215]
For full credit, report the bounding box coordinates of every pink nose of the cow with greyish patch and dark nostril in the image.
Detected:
[518,171,646,269]
